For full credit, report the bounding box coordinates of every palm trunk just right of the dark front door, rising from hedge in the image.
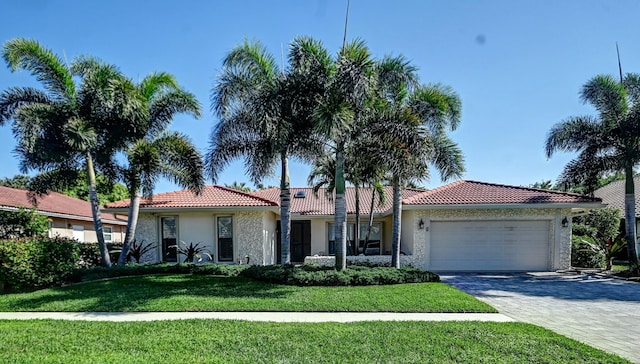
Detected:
[334,144,347,271]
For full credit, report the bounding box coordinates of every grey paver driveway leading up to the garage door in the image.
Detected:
[441,273,640,363]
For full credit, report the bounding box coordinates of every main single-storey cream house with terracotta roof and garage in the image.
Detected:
[105,181,604,271]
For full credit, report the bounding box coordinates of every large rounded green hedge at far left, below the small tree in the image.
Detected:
[0,237,78,291]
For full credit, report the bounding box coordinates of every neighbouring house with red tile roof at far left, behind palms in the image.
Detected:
[0,186,127,243]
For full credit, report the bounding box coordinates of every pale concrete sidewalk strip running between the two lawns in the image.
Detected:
[0,312,516,323]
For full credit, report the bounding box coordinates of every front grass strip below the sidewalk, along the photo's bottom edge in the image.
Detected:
[0,320,628,363]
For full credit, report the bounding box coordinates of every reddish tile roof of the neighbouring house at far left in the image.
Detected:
[0,186,127,225]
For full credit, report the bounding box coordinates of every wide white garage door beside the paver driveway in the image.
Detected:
[429,220,549,271]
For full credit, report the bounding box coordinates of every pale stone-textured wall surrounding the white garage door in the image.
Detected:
[410,209,571,270]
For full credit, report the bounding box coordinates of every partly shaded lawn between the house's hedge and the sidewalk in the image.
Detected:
[0,274,496,312]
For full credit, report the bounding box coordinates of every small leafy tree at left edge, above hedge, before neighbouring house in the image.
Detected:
[0,207,49,239]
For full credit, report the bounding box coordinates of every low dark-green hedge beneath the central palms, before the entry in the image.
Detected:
[241,265,440,286]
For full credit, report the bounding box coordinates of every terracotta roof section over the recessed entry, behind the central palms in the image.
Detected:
[252,187,424,215]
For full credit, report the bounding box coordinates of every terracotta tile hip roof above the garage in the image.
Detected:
[403,180,601,205]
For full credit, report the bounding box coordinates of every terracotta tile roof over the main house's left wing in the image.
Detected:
[105,186,277,209]
